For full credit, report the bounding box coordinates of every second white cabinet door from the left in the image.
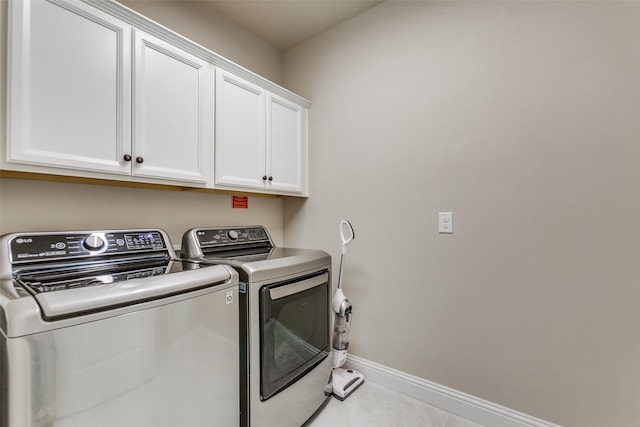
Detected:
[131,31,212,183]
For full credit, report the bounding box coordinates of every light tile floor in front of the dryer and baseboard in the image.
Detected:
[307,381,482,427]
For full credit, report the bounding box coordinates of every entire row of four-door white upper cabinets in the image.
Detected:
[0,0,309,196]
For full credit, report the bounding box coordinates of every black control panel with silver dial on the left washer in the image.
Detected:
[10,230,168,263]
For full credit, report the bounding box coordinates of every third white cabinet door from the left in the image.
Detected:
[215,69,266,189]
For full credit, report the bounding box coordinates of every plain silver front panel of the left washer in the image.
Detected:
[0,286,239,427]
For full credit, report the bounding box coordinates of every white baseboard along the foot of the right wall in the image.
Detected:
[345,355,560,427]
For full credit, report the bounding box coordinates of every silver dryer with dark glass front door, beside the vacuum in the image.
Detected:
[181,226,331,427]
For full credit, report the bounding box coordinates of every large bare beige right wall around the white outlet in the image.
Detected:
[284,1,640,427]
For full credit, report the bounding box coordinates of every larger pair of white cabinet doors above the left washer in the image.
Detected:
[7,0,212,186]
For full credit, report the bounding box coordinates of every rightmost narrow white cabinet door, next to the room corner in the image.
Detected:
[266,94,305,193]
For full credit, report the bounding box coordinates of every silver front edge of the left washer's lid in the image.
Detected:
[0,261,238,337]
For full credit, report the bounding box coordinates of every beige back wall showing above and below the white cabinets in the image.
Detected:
[0,0,284,245]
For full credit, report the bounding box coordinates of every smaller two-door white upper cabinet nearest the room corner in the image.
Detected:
[215,69,306,194]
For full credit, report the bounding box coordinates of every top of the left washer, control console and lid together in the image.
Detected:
[0,229,237,322]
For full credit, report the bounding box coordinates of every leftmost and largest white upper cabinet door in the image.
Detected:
[6,0,131,174]
